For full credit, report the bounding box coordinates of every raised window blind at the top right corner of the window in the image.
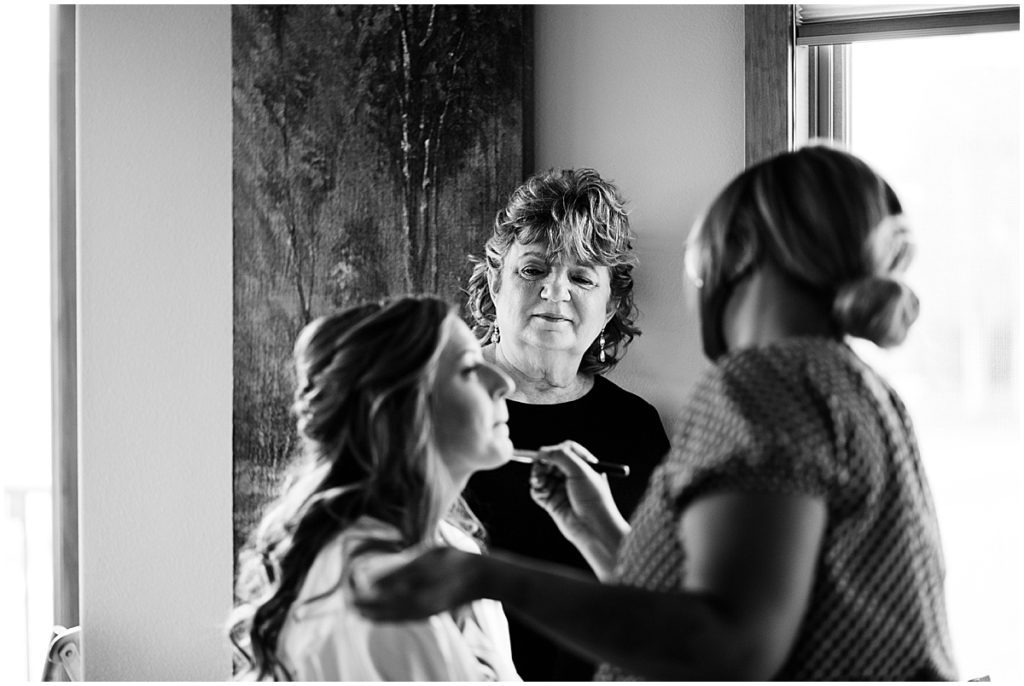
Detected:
[796,4,1020,45]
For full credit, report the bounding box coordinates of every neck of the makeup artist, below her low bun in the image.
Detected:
[725,264,836,350]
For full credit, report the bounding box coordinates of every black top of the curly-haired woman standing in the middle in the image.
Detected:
[466,376,669,681]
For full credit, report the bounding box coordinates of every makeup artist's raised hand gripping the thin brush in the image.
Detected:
[529,440,630,581]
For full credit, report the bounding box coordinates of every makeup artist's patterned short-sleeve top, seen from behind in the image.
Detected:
[597,338,956,681]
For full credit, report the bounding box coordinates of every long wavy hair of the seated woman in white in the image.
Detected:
[228,296,479,680]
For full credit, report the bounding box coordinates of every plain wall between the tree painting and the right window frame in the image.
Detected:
[535,5,743,421]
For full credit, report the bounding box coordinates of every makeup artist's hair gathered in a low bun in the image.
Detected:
[687,144,919,346]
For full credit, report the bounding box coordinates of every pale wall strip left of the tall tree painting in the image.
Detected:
[78,5,231,681]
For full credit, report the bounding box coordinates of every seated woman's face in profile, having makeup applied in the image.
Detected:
[432,315,514,483]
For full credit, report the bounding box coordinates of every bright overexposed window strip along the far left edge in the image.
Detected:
[0,5,53,683]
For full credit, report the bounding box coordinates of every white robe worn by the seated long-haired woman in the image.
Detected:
[278,517,521,681]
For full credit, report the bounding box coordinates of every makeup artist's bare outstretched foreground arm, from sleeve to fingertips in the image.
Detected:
[358,492,825,681]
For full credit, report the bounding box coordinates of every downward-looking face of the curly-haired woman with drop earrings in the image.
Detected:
[490,241,614,359]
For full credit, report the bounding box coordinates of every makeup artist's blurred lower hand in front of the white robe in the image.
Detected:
[346,547,483,621]
